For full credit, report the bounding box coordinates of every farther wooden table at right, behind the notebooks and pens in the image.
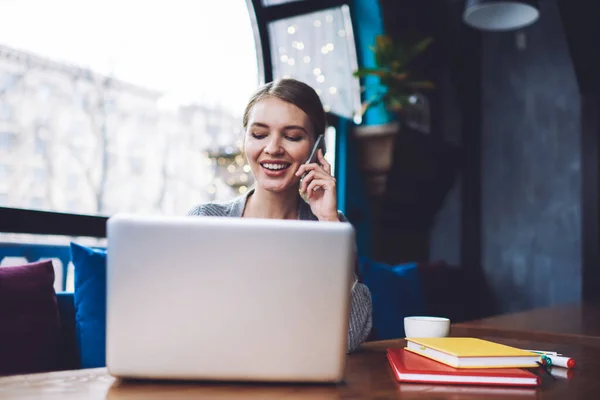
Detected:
[451,302,600,346]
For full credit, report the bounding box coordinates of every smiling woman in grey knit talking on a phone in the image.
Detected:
[189,79,372,351]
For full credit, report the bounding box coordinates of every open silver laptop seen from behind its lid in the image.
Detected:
[106,214,355,383]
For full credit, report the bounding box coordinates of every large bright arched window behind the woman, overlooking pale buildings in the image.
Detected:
[0,0,259,215]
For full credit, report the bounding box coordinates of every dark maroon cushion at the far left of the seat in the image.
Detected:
[0,260,60,375]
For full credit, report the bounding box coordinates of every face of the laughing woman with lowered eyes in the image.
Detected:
[244,97,315,192]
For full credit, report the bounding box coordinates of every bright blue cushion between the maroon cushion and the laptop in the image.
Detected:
[71,243,106,368]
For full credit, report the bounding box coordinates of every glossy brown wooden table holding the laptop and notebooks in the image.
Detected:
[0,337,600,400]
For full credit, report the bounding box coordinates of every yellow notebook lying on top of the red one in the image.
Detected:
[406,337,540,368]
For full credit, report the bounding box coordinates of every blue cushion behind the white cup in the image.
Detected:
[360,257,427,340]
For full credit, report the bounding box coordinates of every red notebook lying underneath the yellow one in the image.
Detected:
[387,349,541,386]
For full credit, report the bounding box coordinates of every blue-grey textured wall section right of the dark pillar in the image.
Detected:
[481,0,581,312]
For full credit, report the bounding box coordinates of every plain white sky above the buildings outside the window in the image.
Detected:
[0,0,258,115]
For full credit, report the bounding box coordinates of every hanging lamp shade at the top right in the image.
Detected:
[463,0,540,31]
